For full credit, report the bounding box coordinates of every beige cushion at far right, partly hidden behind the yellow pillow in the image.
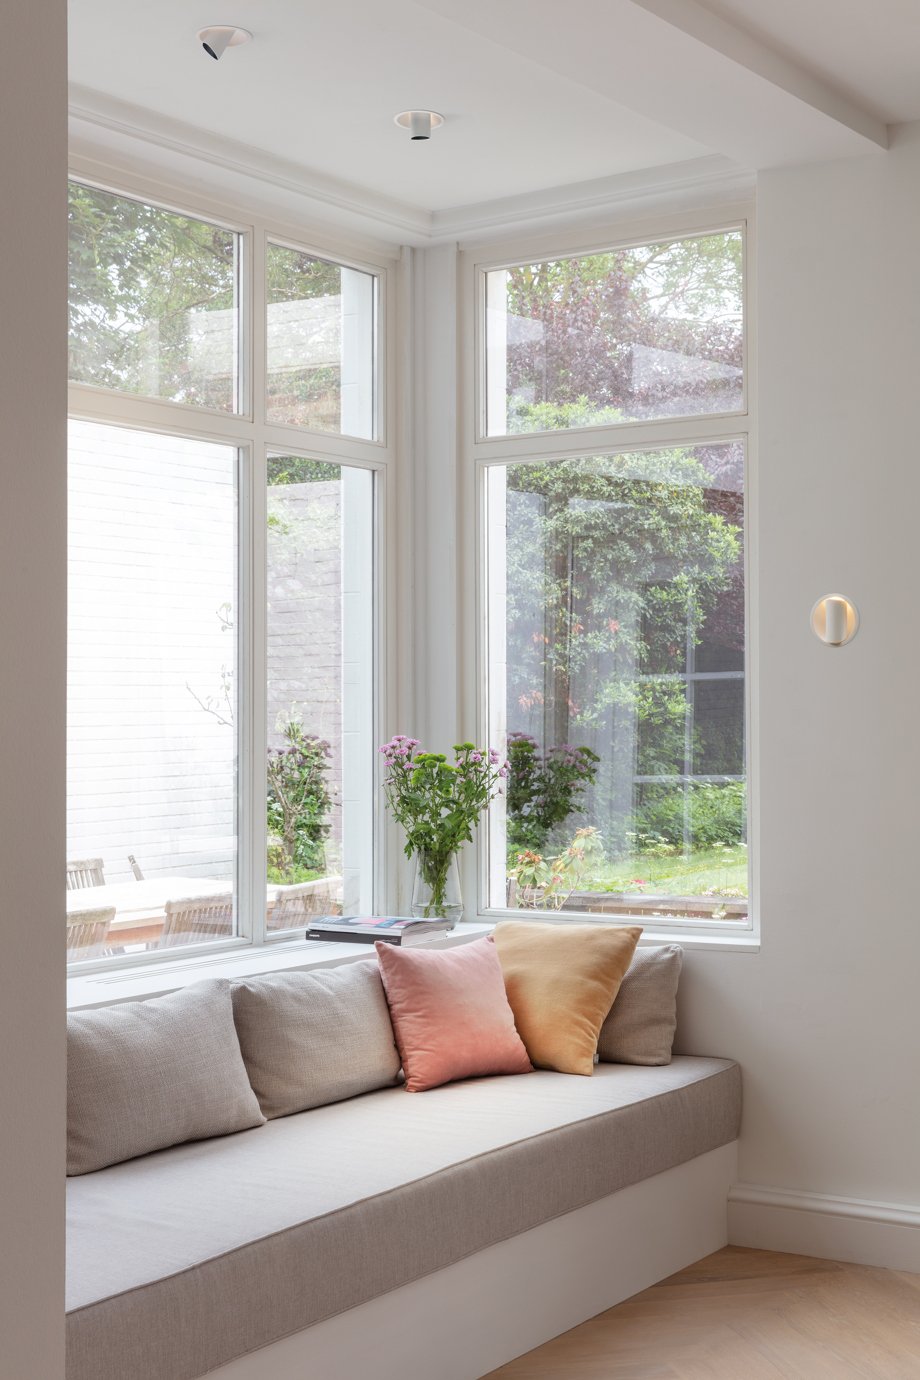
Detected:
[597,944,684,1064]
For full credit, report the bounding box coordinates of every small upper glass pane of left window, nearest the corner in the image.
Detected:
[266,244,377,440]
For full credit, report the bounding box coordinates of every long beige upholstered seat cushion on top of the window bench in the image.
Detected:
[64,1056,741,1380]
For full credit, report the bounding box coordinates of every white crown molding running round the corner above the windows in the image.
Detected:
[70,86,754,250]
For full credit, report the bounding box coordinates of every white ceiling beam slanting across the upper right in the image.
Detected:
[415,0,888,170]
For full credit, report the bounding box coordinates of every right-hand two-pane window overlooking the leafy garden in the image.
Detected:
[474,230,749,926]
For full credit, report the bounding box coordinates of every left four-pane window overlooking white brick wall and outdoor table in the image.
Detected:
[66,182,388,963]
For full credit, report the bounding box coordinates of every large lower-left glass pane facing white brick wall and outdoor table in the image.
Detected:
[66,422,237,959]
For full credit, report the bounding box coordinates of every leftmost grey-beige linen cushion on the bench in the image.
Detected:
[68,978,265,1174]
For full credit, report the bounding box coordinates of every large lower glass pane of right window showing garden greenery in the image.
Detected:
[488,443,748,919]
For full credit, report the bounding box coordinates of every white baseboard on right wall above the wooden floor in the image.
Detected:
[728,1184,920,1274]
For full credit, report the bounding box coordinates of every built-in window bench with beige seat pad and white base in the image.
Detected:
[68,965,741,1380]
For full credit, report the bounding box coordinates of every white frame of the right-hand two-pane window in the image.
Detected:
[458,203,760,947]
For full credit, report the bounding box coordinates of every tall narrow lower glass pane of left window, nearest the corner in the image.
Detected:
[268,455,375,932]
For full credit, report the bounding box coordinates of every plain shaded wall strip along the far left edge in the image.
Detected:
[0,0,66,1380]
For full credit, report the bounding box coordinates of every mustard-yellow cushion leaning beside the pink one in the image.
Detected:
[495,920,641,1074]
